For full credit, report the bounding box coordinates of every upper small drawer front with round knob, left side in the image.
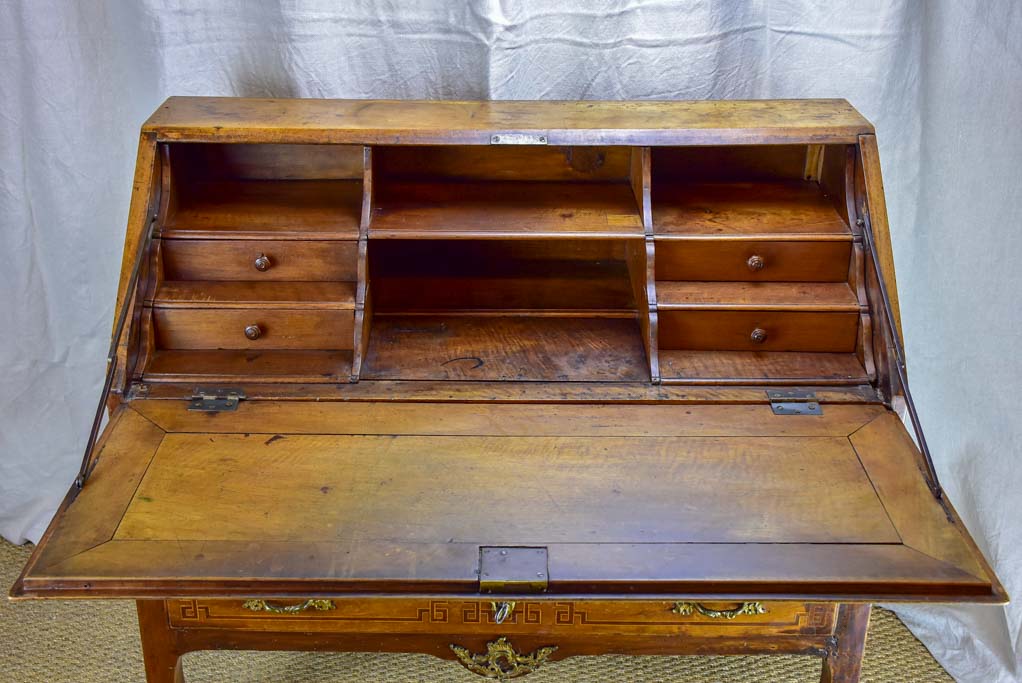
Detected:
[162,239,359,282]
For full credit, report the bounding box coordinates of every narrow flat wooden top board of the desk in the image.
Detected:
[142,97,873,145]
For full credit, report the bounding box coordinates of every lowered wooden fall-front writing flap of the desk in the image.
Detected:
[13,400,1004,601]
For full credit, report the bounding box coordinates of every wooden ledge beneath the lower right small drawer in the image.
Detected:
[660,349,869,384]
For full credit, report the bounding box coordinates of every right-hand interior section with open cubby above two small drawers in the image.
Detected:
[651,145,869,383]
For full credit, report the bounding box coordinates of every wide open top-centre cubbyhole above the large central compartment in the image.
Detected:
[369,145,644,238]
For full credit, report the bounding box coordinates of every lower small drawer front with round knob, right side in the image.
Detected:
[659,311,858,352]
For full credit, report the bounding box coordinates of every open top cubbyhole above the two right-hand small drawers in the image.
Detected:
[652,145,851,238]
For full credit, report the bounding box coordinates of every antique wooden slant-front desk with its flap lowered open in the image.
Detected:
[12,98,1007,683]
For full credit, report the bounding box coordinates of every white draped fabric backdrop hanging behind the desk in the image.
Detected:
[0,0,1022,683]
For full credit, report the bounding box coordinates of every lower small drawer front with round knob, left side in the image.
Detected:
[153,309,355,351]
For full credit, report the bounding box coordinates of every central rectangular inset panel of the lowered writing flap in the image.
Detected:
[114,434,898,546]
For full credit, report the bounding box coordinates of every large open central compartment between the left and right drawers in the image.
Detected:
[361,239,649,381]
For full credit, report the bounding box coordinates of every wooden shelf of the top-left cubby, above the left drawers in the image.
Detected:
[162,180,362,239]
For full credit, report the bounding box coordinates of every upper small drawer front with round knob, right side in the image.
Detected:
[655,239,851,282]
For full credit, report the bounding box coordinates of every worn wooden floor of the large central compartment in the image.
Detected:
[361,314,649,381]
